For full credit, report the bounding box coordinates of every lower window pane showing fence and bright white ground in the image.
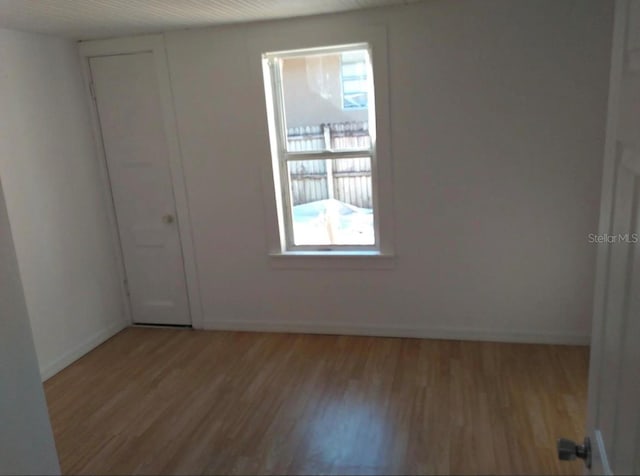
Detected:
[287,157,375,246]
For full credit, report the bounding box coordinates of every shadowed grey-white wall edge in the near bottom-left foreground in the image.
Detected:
[0,178,60,474]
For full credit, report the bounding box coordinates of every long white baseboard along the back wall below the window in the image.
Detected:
[204,319,591,345]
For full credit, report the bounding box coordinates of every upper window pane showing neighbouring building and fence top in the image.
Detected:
[281,50,371,152]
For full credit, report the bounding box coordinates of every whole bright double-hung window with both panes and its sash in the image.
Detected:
[263,44,379,253]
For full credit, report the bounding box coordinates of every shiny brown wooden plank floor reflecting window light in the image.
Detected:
[45,328,588,474]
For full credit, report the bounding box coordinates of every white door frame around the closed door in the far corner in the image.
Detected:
[78,34,204,329]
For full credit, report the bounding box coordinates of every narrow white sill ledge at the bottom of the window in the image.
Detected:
[269,251,396,269]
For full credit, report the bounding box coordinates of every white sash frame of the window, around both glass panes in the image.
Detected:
[262,43,380,254]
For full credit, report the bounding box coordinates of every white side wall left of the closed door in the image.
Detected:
[0,29,124,378]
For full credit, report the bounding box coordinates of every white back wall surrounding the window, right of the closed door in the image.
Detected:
[160,0,613,343]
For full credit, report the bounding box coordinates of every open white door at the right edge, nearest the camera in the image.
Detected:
[576,0,640,474]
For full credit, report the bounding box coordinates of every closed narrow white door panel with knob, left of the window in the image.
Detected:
[89,52,191,325]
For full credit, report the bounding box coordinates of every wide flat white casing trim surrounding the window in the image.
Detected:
[247,25,397,264]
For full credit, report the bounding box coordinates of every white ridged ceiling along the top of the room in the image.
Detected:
[0,0,417,40]
